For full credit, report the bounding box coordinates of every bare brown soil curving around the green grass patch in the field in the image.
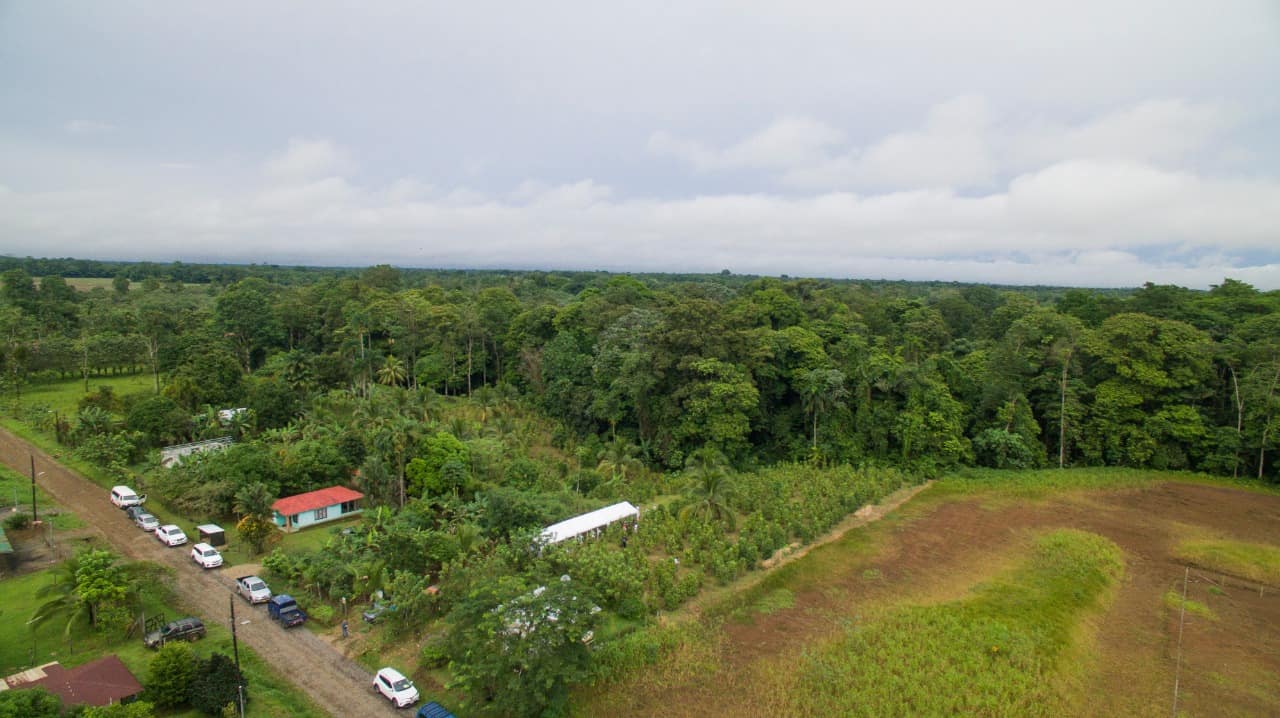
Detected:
[601,483,1280,718]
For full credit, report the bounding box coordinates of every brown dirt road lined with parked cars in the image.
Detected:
[0,429,398,718]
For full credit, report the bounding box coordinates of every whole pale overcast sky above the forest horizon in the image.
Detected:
[0,0,1280,289]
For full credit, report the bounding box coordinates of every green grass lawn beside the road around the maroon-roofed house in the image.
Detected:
[0,563,324,718]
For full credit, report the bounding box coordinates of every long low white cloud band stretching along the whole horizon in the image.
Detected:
[0,135,1280,289]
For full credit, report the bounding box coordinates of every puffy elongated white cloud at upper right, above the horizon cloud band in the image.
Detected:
[648,95,1242,191]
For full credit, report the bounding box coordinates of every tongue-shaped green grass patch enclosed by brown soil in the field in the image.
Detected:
[776,530,1124,715]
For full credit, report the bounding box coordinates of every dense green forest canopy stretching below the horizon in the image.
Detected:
[0,259,1280,479]
